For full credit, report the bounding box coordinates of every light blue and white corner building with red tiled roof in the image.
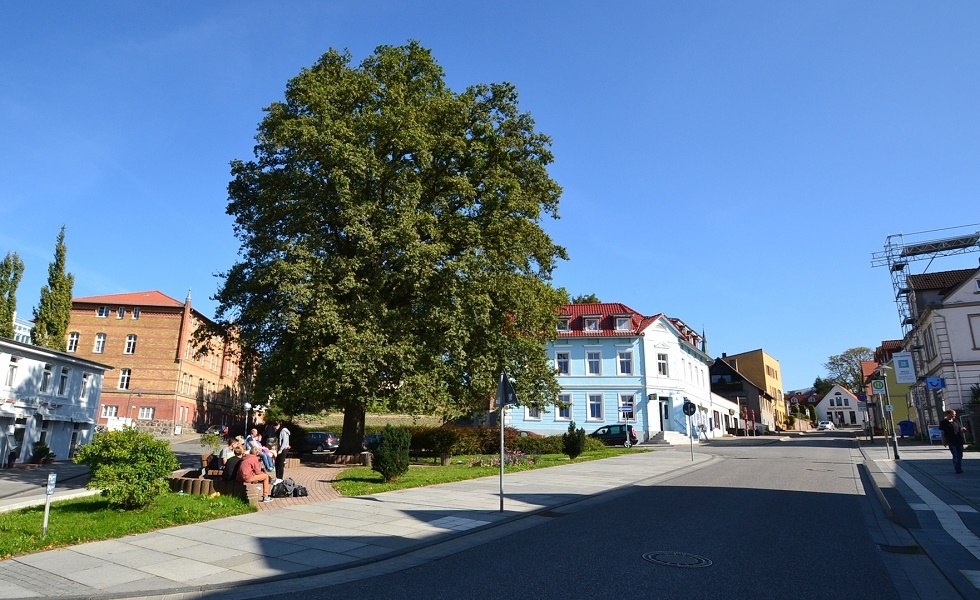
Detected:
[506,303,717,442]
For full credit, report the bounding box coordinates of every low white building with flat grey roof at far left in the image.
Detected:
[0,338,112,464]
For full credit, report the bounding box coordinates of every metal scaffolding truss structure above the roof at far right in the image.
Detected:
[871,223,980,337]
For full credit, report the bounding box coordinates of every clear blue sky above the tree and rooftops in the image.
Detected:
[0,0,980,389]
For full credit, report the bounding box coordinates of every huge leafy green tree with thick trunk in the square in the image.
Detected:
[216,42,568,452]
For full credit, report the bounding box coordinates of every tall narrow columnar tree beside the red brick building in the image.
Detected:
[31,226,75,351]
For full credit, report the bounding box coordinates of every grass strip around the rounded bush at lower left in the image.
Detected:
[0,493,255,559]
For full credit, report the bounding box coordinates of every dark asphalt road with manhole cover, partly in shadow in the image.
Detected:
[235,435,940,600]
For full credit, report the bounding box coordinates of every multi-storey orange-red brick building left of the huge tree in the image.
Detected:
[68,291,243,435]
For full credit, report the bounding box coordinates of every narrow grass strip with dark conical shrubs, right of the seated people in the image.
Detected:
[333,447,651,496]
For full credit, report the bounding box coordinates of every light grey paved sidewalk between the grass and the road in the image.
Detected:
[0,448,712,598]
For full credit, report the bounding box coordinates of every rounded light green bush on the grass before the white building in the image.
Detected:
[75,427,180,510]
